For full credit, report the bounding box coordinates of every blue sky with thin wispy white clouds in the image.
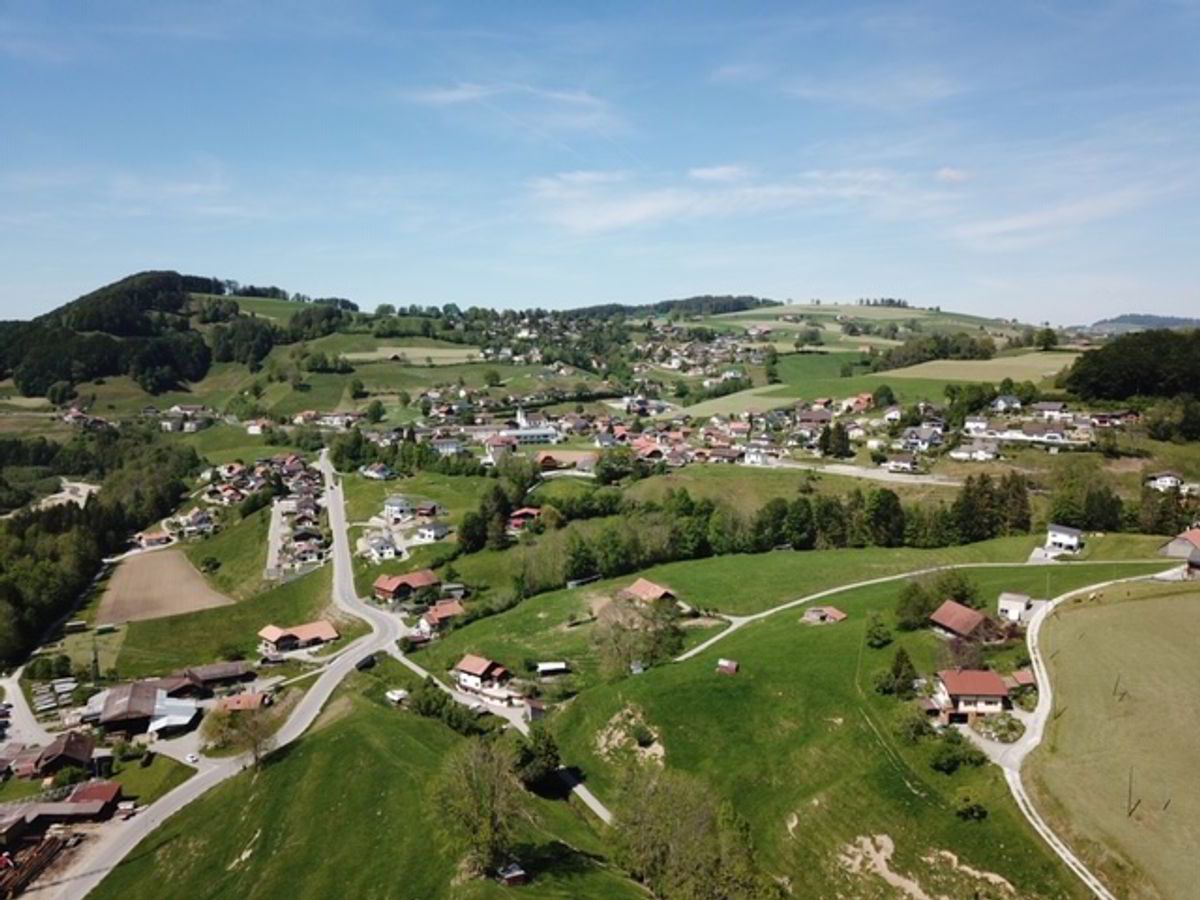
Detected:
[0,0,1200,323]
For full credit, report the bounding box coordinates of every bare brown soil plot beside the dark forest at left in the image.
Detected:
[96,548,234,625]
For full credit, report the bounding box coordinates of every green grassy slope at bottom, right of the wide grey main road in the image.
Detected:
[94,676,644,900]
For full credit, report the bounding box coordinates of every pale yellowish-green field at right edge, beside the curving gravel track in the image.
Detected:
[1026,583,1200,900]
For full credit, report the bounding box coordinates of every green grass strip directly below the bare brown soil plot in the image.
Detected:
[116,566,355,678]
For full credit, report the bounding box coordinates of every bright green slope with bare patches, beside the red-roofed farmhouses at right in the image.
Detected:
[552,566,1171,896]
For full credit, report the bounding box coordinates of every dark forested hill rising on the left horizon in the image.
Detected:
[0,271,353,403]
